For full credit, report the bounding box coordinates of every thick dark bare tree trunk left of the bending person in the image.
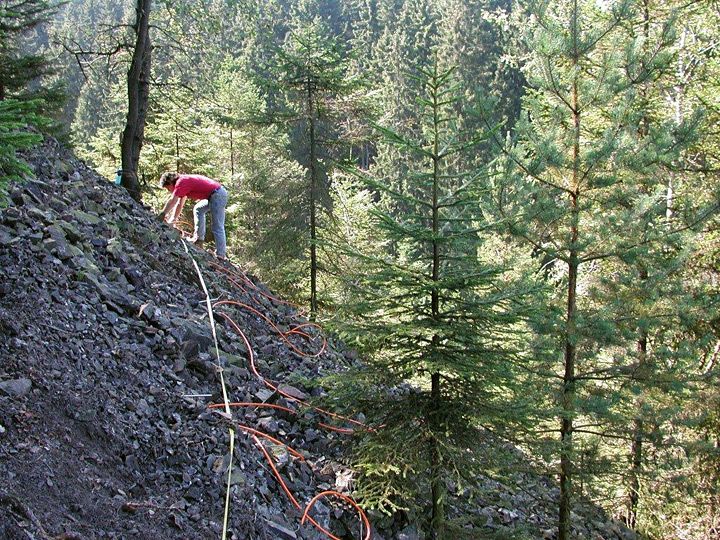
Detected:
[121,0,152,201]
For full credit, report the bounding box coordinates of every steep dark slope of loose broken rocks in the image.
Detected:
[0,141,632,540]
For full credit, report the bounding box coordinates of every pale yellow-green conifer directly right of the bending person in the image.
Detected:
[209,59,306,286]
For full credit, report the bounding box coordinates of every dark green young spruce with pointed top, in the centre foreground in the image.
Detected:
[336,57,528,538]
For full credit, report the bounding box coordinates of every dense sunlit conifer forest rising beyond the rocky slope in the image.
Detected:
[0,0,720,540]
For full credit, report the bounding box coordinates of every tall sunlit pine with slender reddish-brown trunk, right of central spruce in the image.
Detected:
[496,0,716,540]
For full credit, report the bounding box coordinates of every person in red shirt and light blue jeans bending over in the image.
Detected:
[158,172,227,259]
